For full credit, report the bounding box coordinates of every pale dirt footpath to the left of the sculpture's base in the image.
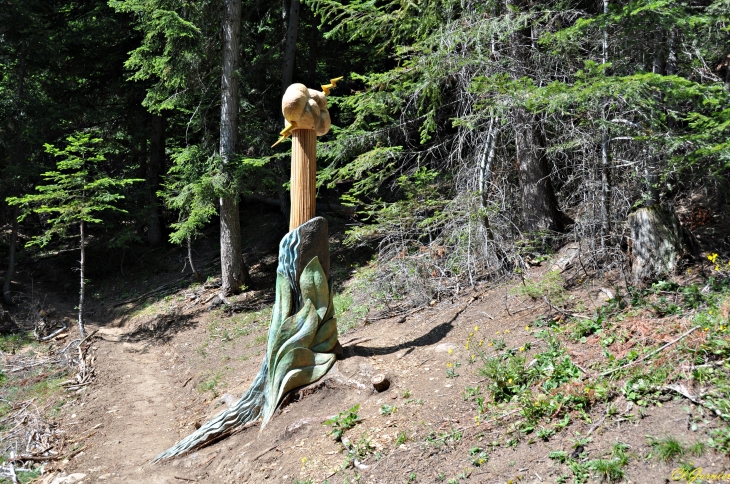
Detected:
[62,341,181,483]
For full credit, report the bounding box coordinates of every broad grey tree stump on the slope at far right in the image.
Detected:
[628,205,692,284]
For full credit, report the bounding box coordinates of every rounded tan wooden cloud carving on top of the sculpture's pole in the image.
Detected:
[281,84,331,136]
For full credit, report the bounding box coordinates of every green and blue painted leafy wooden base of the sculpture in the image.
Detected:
[153,217,337,462]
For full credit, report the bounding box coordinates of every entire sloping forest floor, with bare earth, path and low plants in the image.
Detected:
[0,206,730,484]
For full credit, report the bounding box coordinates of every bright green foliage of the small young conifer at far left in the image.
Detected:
[7,133,142,246]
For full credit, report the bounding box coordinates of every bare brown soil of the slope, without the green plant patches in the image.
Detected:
[29,278,730,483]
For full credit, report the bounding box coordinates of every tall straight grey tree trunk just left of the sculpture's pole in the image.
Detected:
[220,0,250,295]
